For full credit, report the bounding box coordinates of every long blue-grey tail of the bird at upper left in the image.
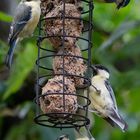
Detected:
[5,39,17,68]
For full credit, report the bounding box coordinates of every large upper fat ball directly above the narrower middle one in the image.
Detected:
[44,4,83,49]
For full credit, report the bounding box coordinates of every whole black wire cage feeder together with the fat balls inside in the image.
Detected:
[35,0,93,128]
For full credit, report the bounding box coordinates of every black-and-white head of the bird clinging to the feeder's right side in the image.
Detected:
[92,65,110,79]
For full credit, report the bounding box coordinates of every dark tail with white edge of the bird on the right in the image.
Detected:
[105,110,128,132]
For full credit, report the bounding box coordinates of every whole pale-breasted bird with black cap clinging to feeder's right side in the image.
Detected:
[89,64,128,132]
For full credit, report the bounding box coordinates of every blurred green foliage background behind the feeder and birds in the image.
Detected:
[0,0,140,140]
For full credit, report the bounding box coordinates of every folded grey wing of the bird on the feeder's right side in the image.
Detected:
[105,80,118,110]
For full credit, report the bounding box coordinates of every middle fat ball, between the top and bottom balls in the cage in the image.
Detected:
[53,45,87,87]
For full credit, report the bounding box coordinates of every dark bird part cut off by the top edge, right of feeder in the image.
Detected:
[98,0,130,9]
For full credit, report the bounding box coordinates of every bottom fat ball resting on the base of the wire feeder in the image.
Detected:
[40,76,77,117]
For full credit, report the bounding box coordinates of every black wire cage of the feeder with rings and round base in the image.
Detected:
[34,0,94,129]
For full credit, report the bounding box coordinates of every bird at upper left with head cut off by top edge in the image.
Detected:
[6,0,41,67]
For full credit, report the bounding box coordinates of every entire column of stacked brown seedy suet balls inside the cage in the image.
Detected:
[39,0,87,121]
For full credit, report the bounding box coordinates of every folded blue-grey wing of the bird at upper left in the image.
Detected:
[8,3,31,44]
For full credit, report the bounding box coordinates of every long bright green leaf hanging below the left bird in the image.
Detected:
[3,44,37,99]
